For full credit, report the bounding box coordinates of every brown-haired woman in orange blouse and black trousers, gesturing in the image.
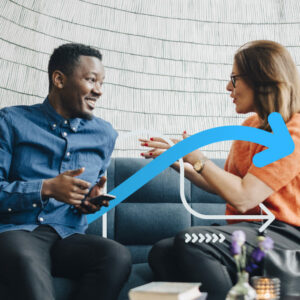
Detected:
[141,41,300,299]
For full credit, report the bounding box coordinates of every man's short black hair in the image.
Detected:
[48,43,102,91]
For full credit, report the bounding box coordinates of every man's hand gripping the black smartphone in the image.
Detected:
[75,176,109,214]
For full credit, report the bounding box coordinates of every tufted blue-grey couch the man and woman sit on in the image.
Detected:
[0,158,225,300]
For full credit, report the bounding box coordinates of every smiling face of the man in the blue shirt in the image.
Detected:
[61,56,105,120]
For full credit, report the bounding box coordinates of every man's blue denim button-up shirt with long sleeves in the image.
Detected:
[0,98,117,238]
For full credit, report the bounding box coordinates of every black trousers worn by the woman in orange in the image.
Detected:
[149,221,300,300]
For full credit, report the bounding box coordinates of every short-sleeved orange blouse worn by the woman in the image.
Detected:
[224,113,300,226]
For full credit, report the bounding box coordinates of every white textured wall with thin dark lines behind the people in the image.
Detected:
[0,0,300,158]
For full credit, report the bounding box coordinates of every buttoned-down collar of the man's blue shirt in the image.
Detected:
[42,97,81,132]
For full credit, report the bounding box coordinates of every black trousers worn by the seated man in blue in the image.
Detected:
[0,225,131,300]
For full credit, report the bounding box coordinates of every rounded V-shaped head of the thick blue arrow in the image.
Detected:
[253,112,295,168]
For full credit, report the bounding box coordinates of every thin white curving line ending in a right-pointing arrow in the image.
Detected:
[119,130,275,232]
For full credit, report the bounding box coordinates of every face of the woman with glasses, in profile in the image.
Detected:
[226,62,255,114]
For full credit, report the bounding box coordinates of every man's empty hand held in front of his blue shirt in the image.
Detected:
[41,168,90,206]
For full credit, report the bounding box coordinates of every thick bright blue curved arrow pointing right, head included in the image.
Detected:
[87,113,295,223]
